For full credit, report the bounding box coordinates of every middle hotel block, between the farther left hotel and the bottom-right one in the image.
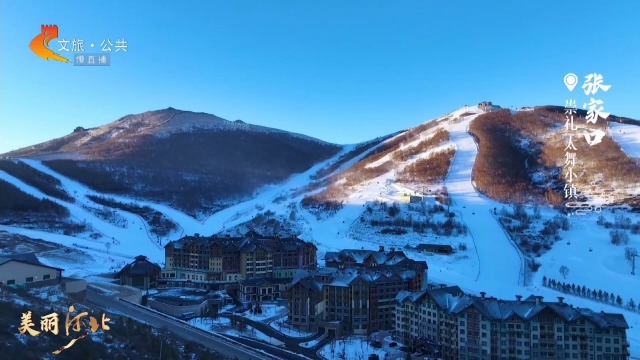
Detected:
[287,250,427,336]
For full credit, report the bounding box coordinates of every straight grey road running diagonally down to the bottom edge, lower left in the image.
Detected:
[86,288,270,360]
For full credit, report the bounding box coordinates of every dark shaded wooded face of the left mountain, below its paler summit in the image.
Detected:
[45,129,341,216]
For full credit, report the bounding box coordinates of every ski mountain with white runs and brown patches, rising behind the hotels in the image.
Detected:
[0,106,640,356]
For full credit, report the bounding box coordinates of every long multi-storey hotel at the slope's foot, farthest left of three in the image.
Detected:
[161,231,317,285]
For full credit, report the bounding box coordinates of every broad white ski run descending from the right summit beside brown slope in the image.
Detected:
[445,115,523,298]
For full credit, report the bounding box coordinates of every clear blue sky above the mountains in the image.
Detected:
[0,0,640,152]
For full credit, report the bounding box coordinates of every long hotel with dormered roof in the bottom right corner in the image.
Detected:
[395,286,629,360]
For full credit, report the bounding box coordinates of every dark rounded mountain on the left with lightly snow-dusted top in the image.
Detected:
[1,108,350,216]
